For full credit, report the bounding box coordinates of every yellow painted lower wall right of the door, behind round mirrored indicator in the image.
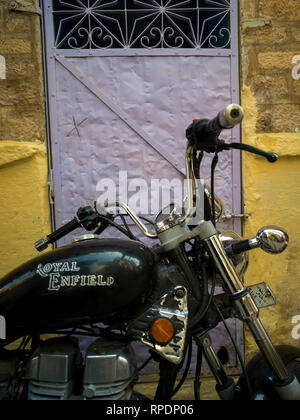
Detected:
[242,88,300,357]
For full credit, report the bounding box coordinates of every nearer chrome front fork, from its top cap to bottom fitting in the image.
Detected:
[200,222,300,400]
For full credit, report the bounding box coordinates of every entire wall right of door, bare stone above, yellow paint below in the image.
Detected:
[240,0,300,359]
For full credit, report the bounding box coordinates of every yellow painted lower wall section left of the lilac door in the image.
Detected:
[0,141,51,277]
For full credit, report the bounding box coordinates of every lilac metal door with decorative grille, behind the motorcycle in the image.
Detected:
[43,0,242,380]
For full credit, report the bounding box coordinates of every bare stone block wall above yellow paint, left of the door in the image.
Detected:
[0,0,46,141]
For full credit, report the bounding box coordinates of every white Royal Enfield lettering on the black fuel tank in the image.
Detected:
[36,261,115,291]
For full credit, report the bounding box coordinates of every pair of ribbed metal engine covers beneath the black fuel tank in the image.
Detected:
[26,337,138,400]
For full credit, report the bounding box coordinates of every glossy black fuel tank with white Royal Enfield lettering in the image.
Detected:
[0,239,157,337]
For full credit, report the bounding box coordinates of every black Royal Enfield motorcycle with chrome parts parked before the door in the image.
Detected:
[0,104,300,401]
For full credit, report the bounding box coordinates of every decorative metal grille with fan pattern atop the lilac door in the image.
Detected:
[53,0,230,49]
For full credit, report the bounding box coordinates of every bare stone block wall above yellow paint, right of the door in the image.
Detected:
[240,0,300,133]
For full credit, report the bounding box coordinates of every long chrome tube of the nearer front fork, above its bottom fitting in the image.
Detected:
[201,228,289,382]
